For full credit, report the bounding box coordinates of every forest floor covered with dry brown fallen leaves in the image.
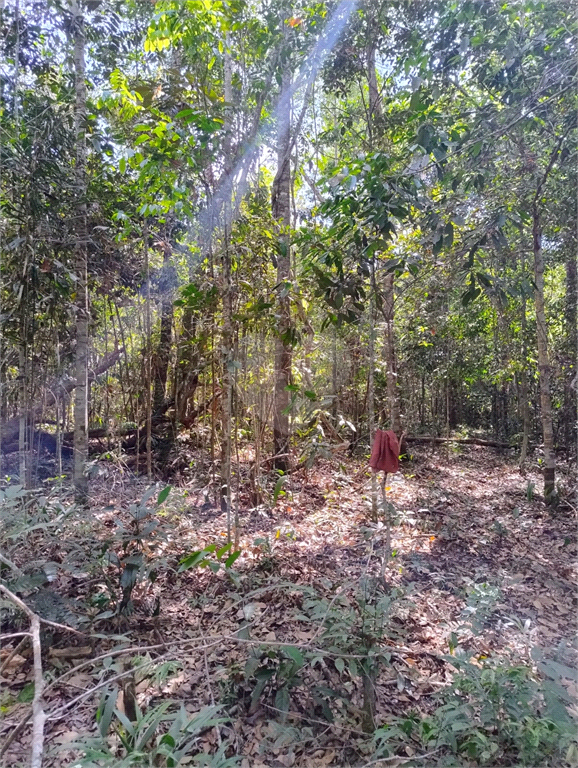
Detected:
[0,446,577,768]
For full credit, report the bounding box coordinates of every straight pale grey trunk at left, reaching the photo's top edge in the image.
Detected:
[71,0,88,503]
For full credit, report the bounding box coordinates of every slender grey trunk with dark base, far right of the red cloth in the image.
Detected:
[532,199,556,504]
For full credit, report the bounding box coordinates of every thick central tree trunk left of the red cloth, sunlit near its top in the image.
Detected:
[271,46,292,471]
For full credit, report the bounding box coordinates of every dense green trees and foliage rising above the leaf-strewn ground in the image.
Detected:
[0,0,576,498]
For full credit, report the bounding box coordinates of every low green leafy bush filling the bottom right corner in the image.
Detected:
[374,657,578,768]
